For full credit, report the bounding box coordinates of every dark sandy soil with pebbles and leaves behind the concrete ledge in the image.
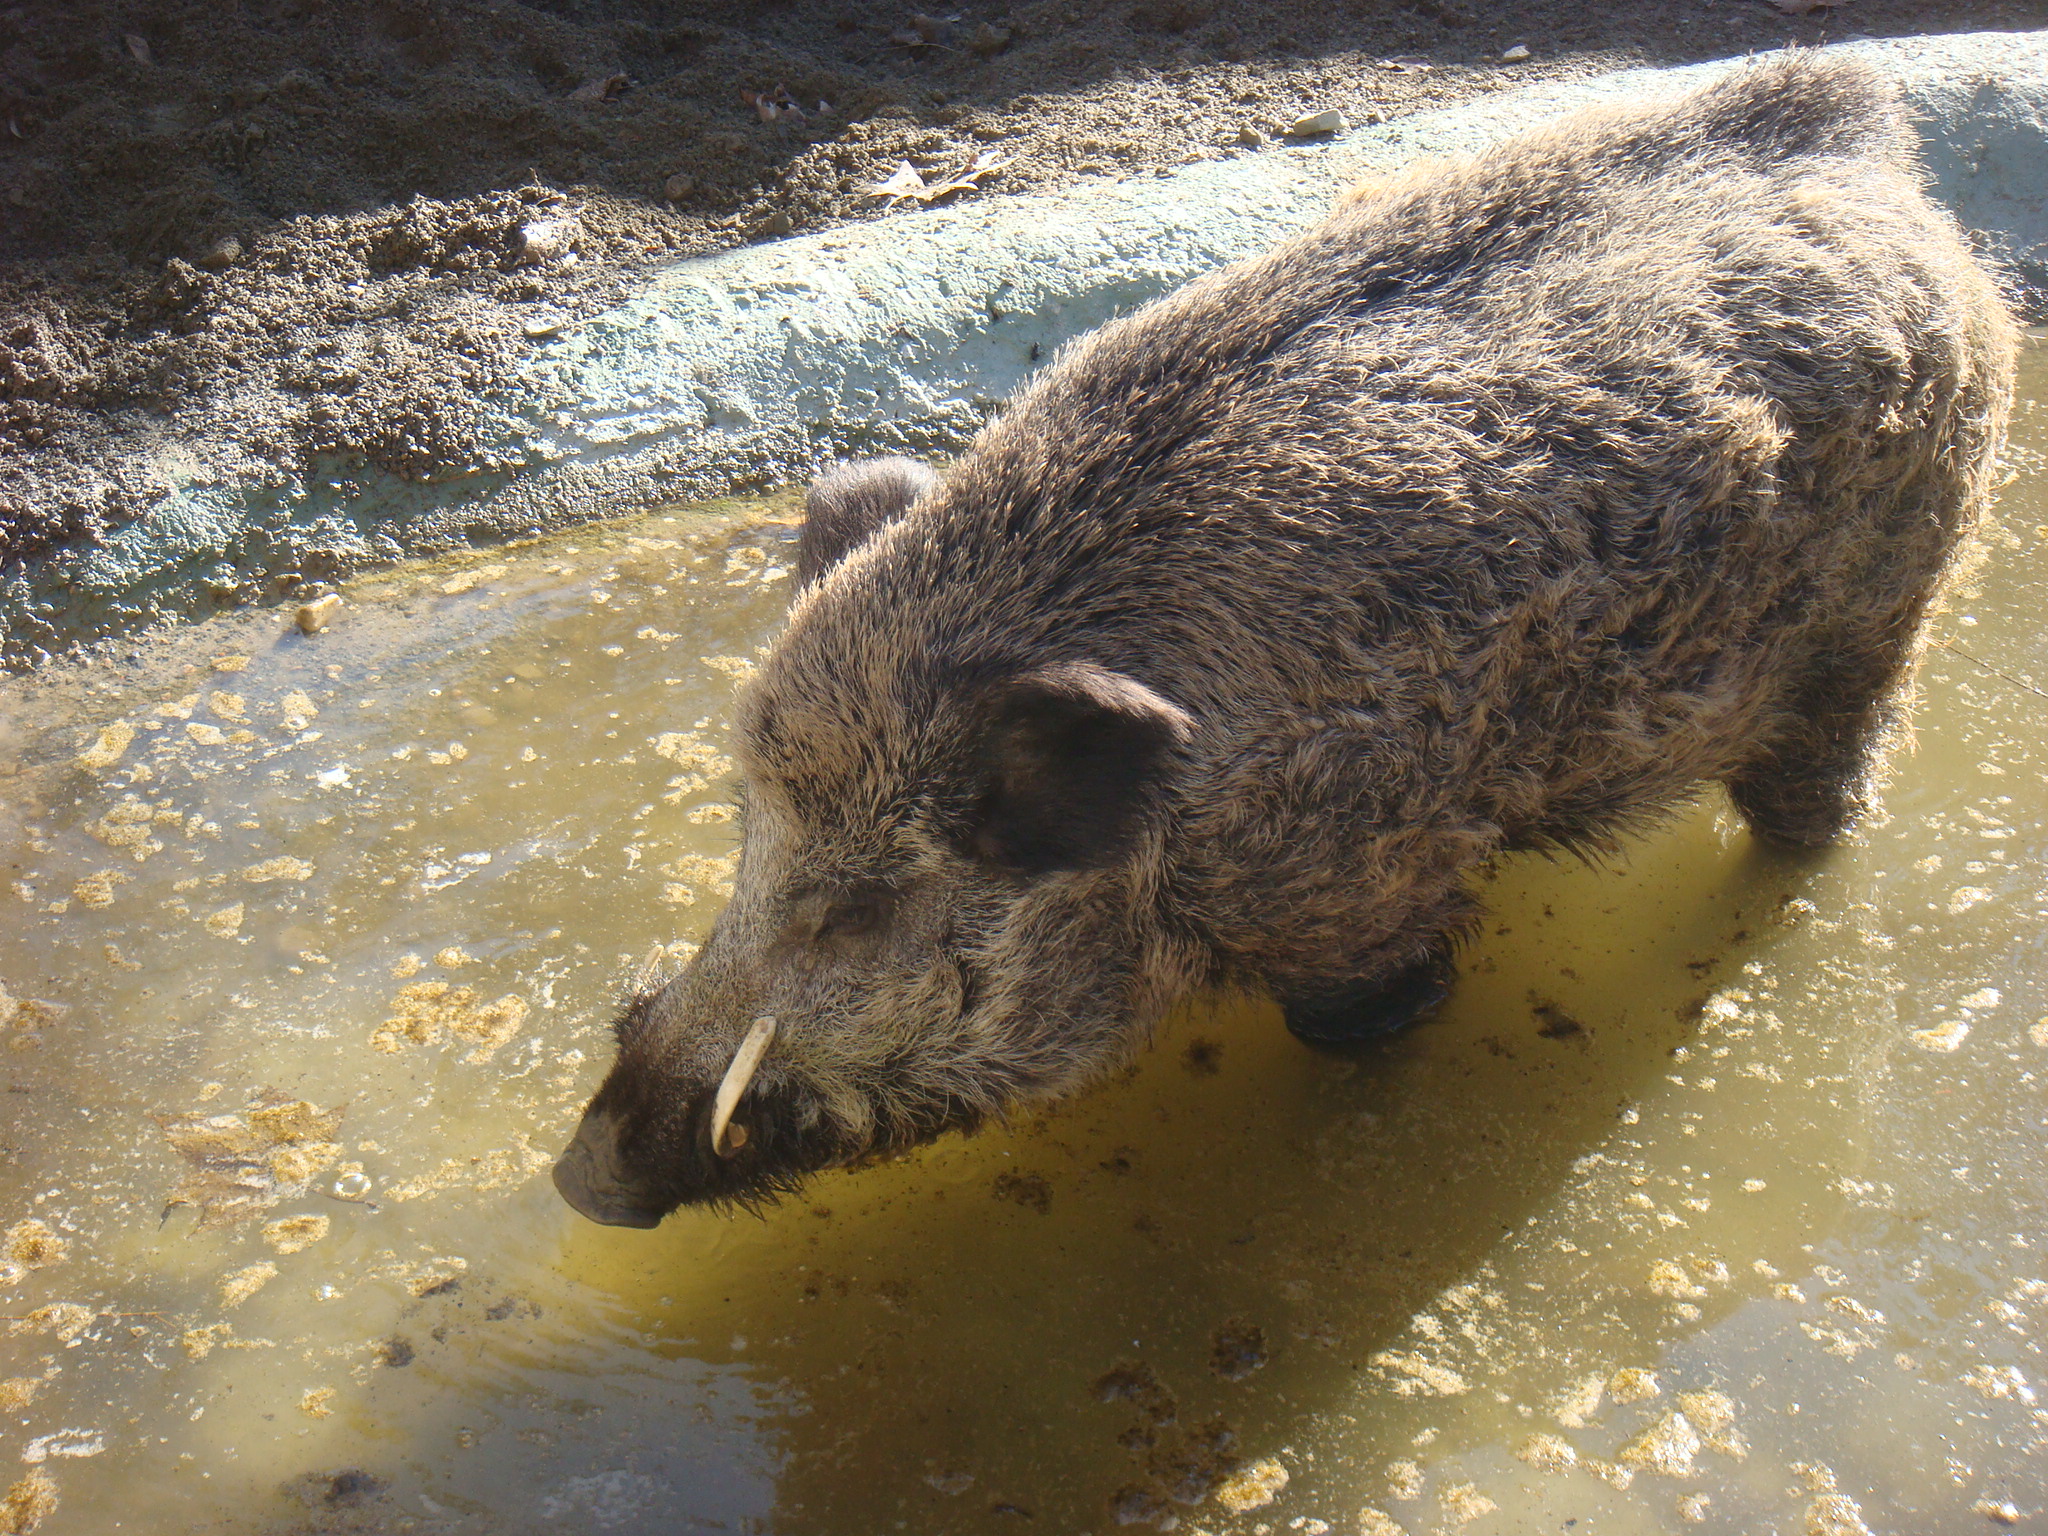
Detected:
[0,0,2048,571]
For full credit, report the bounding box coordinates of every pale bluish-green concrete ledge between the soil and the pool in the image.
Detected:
[0,31,2048,662]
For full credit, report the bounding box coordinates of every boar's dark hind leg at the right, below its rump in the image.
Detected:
[1729,626,1919,848]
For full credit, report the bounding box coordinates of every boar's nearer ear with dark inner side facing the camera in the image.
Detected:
[969,662,1194,877]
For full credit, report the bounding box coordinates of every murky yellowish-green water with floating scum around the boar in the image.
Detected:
[0,350,2048,1536]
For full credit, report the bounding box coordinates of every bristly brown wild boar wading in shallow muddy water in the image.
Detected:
[555,57,2015,1225]
